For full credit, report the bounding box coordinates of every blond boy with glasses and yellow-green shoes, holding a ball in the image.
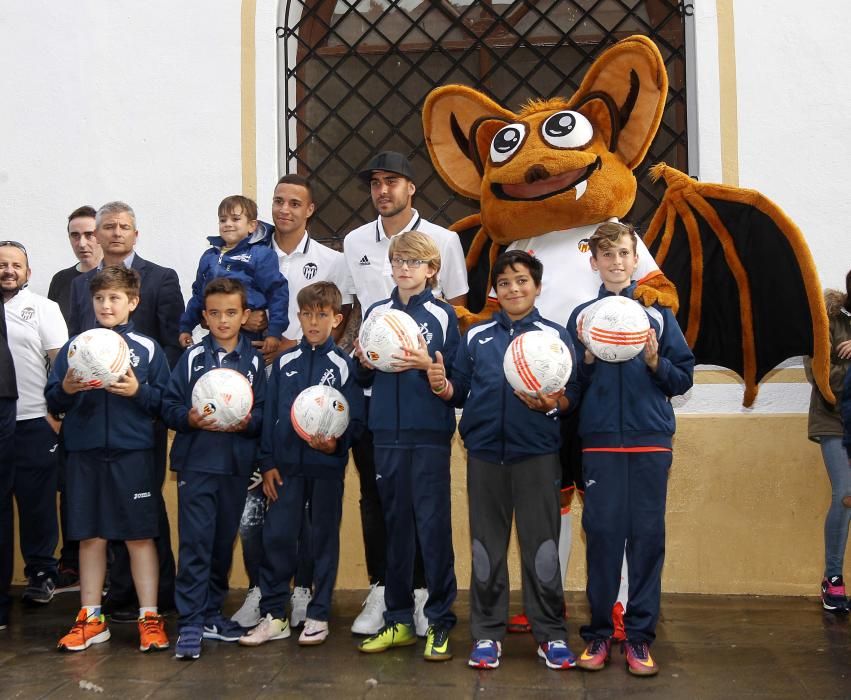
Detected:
[357,231,460,661]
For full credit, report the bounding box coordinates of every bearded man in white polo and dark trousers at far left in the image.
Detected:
[0,241,68,604]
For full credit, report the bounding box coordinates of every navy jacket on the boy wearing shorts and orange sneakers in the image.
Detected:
[44,323,168,452]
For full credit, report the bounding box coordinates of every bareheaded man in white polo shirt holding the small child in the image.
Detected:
[233,174,352,627]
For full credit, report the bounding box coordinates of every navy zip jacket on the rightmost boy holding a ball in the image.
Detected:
[567,282,694,449]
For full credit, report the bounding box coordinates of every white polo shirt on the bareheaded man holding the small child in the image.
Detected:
[271,231,352,340]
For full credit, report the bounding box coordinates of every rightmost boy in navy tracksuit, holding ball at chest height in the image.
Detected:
[568,223,694,676]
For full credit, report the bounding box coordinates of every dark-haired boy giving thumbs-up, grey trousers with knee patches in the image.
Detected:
[429,251,579,669]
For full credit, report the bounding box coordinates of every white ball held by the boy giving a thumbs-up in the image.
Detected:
[502,331,573,395]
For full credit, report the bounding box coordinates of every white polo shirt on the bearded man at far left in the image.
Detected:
[3,289,68,420]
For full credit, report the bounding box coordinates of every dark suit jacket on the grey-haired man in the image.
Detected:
[68,253,183,367]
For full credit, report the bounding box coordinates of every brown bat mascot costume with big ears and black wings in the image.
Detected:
[423,36,833,628]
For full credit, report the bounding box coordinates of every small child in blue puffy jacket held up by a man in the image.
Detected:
[180,195,289,355]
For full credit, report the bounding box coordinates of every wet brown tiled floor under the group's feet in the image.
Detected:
[0,591,851,700]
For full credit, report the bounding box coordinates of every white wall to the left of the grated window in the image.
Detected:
[0,0,277,304]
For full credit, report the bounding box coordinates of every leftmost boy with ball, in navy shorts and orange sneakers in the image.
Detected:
[45,266,168,651]
